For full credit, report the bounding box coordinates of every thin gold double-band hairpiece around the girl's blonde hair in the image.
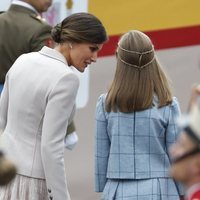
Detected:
[117,44,155,71]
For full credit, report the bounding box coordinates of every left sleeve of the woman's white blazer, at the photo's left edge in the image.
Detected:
[0,74,9,134]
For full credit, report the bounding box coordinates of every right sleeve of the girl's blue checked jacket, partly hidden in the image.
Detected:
[166,97,184,195]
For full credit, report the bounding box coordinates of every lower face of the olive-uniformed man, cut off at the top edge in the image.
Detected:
[25,0,52,13]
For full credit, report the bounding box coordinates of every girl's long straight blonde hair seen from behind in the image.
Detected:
[106,30,172,112]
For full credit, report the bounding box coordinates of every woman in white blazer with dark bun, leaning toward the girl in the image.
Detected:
[0,13,107,200]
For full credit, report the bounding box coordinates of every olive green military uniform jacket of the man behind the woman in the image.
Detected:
[0,4,75,134]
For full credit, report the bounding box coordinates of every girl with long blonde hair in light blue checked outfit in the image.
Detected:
[95,30,182,200]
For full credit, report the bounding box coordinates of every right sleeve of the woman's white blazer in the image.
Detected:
[41,73,79,200]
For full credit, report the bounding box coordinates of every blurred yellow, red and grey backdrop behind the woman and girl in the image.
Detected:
[0,0,200,200]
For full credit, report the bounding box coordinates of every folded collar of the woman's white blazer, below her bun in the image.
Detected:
[39,46,68,65]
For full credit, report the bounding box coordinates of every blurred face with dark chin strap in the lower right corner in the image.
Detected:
[170,133,200,187]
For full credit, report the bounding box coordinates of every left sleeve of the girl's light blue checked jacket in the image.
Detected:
[95,95,110,192]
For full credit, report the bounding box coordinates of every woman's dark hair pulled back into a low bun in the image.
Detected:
[51,12,108,44]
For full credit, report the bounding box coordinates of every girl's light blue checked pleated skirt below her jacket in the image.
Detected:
[101,178,179,200]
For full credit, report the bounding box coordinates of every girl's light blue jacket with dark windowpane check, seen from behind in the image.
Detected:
[95,94,183,192]
